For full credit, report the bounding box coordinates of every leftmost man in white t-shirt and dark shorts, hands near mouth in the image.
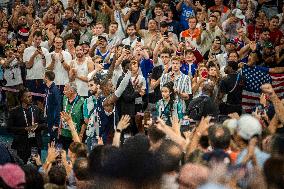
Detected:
[23,31,51,105]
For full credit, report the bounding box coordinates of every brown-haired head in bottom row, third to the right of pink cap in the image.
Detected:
[73,158,89,180]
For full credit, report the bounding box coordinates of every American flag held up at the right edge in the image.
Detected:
[242,65,284,113]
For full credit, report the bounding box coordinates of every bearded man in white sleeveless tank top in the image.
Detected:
[69,45,94,97]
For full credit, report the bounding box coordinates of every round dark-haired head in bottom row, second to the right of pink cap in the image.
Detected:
[48,165,67,186]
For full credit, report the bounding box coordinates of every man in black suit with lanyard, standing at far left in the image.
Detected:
[8,89,45,163]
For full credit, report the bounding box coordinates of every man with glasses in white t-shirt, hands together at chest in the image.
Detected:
[46,36,72,93]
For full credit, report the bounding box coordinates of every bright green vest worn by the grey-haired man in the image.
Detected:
[61,96,84,138]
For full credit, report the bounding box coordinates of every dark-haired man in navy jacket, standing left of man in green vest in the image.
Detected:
[44,71,62,141]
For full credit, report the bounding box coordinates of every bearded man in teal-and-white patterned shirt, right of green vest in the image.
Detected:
[83,76,100,150]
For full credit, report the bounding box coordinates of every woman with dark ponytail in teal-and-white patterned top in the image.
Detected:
[156,82,183,126]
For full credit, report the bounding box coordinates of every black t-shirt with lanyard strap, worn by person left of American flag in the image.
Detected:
[220,73,244,105]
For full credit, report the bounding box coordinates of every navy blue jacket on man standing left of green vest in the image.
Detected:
[45,83,62,126]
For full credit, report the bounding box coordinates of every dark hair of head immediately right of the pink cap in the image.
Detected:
[23,164,44,189]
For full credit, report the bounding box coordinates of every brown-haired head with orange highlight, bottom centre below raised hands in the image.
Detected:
[156,139,182,172]
